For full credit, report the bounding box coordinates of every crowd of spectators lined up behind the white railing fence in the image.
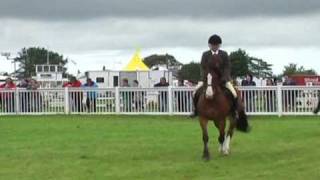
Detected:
[0,74,318,112]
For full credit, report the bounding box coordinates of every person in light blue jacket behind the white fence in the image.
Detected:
[82,78,98,112]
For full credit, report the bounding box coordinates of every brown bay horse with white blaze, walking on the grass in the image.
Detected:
[196,55,249,160]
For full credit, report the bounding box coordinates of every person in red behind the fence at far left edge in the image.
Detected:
[0,78,16,112]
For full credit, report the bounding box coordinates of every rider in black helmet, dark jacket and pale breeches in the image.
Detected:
[191,34,238,117]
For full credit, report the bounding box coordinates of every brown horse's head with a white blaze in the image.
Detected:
[205,55,222,99]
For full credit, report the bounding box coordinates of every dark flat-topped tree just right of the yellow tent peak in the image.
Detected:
[143,54,182,69]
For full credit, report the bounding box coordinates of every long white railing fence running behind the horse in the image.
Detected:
[0,86,320,116]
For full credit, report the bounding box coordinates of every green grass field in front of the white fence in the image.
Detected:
[0,116,320,180]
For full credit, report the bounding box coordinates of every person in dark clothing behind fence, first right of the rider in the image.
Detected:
[241,74,256,112]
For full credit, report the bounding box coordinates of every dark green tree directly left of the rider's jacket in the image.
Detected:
[178,62,201,82]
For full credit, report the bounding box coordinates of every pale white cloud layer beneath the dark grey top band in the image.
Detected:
[0,14,320,73]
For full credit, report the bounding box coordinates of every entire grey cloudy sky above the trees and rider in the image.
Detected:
[0,0,320,74]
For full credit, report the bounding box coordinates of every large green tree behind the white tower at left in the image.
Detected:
[15,47,68,78]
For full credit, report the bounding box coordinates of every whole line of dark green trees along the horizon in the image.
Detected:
[7,47,317,82]
